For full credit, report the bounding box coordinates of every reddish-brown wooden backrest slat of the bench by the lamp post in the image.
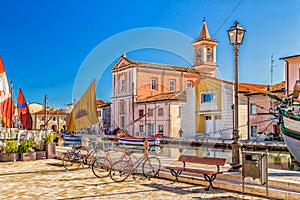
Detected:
[178,155,226,166]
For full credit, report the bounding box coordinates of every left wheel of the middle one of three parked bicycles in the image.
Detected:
[92,157,111,178]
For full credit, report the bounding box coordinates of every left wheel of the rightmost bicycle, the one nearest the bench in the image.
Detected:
[110,160,132,182]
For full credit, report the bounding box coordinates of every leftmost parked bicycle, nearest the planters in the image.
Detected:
[62,145,96,171]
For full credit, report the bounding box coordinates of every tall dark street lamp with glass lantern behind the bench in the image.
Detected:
[227,21,246,171]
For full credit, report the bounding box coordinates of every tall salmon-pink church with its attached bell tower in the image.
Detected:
[111,21,217,135]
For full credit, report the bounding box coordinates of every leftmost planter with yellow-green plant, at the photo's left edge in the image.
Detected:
[0,140,20,162]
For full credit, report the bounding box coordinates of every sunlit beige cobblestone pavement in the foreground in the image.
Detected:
[0,159,270,200]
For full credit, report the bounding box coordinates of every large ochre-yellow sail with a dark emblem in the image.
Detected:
[67,80,98,132]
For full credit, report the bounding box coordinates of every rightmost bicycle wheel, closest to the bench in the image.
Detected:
[142,157,161,178]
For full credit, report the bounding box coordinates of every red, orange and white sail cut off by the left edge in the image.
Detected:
[0,56,14,128]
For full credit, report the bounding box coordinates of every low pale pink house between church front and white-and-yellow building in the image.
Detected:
[134,92,186,137]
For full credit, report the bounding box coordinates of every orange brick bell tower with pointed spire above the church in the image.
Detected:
[192,18,218,77]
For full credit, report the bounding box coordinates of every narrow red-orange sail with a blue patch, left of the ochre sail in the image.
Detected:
[17,88,31,130]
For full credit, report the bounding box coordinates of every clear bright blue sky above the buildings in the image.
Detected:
[0,0,300,109]
